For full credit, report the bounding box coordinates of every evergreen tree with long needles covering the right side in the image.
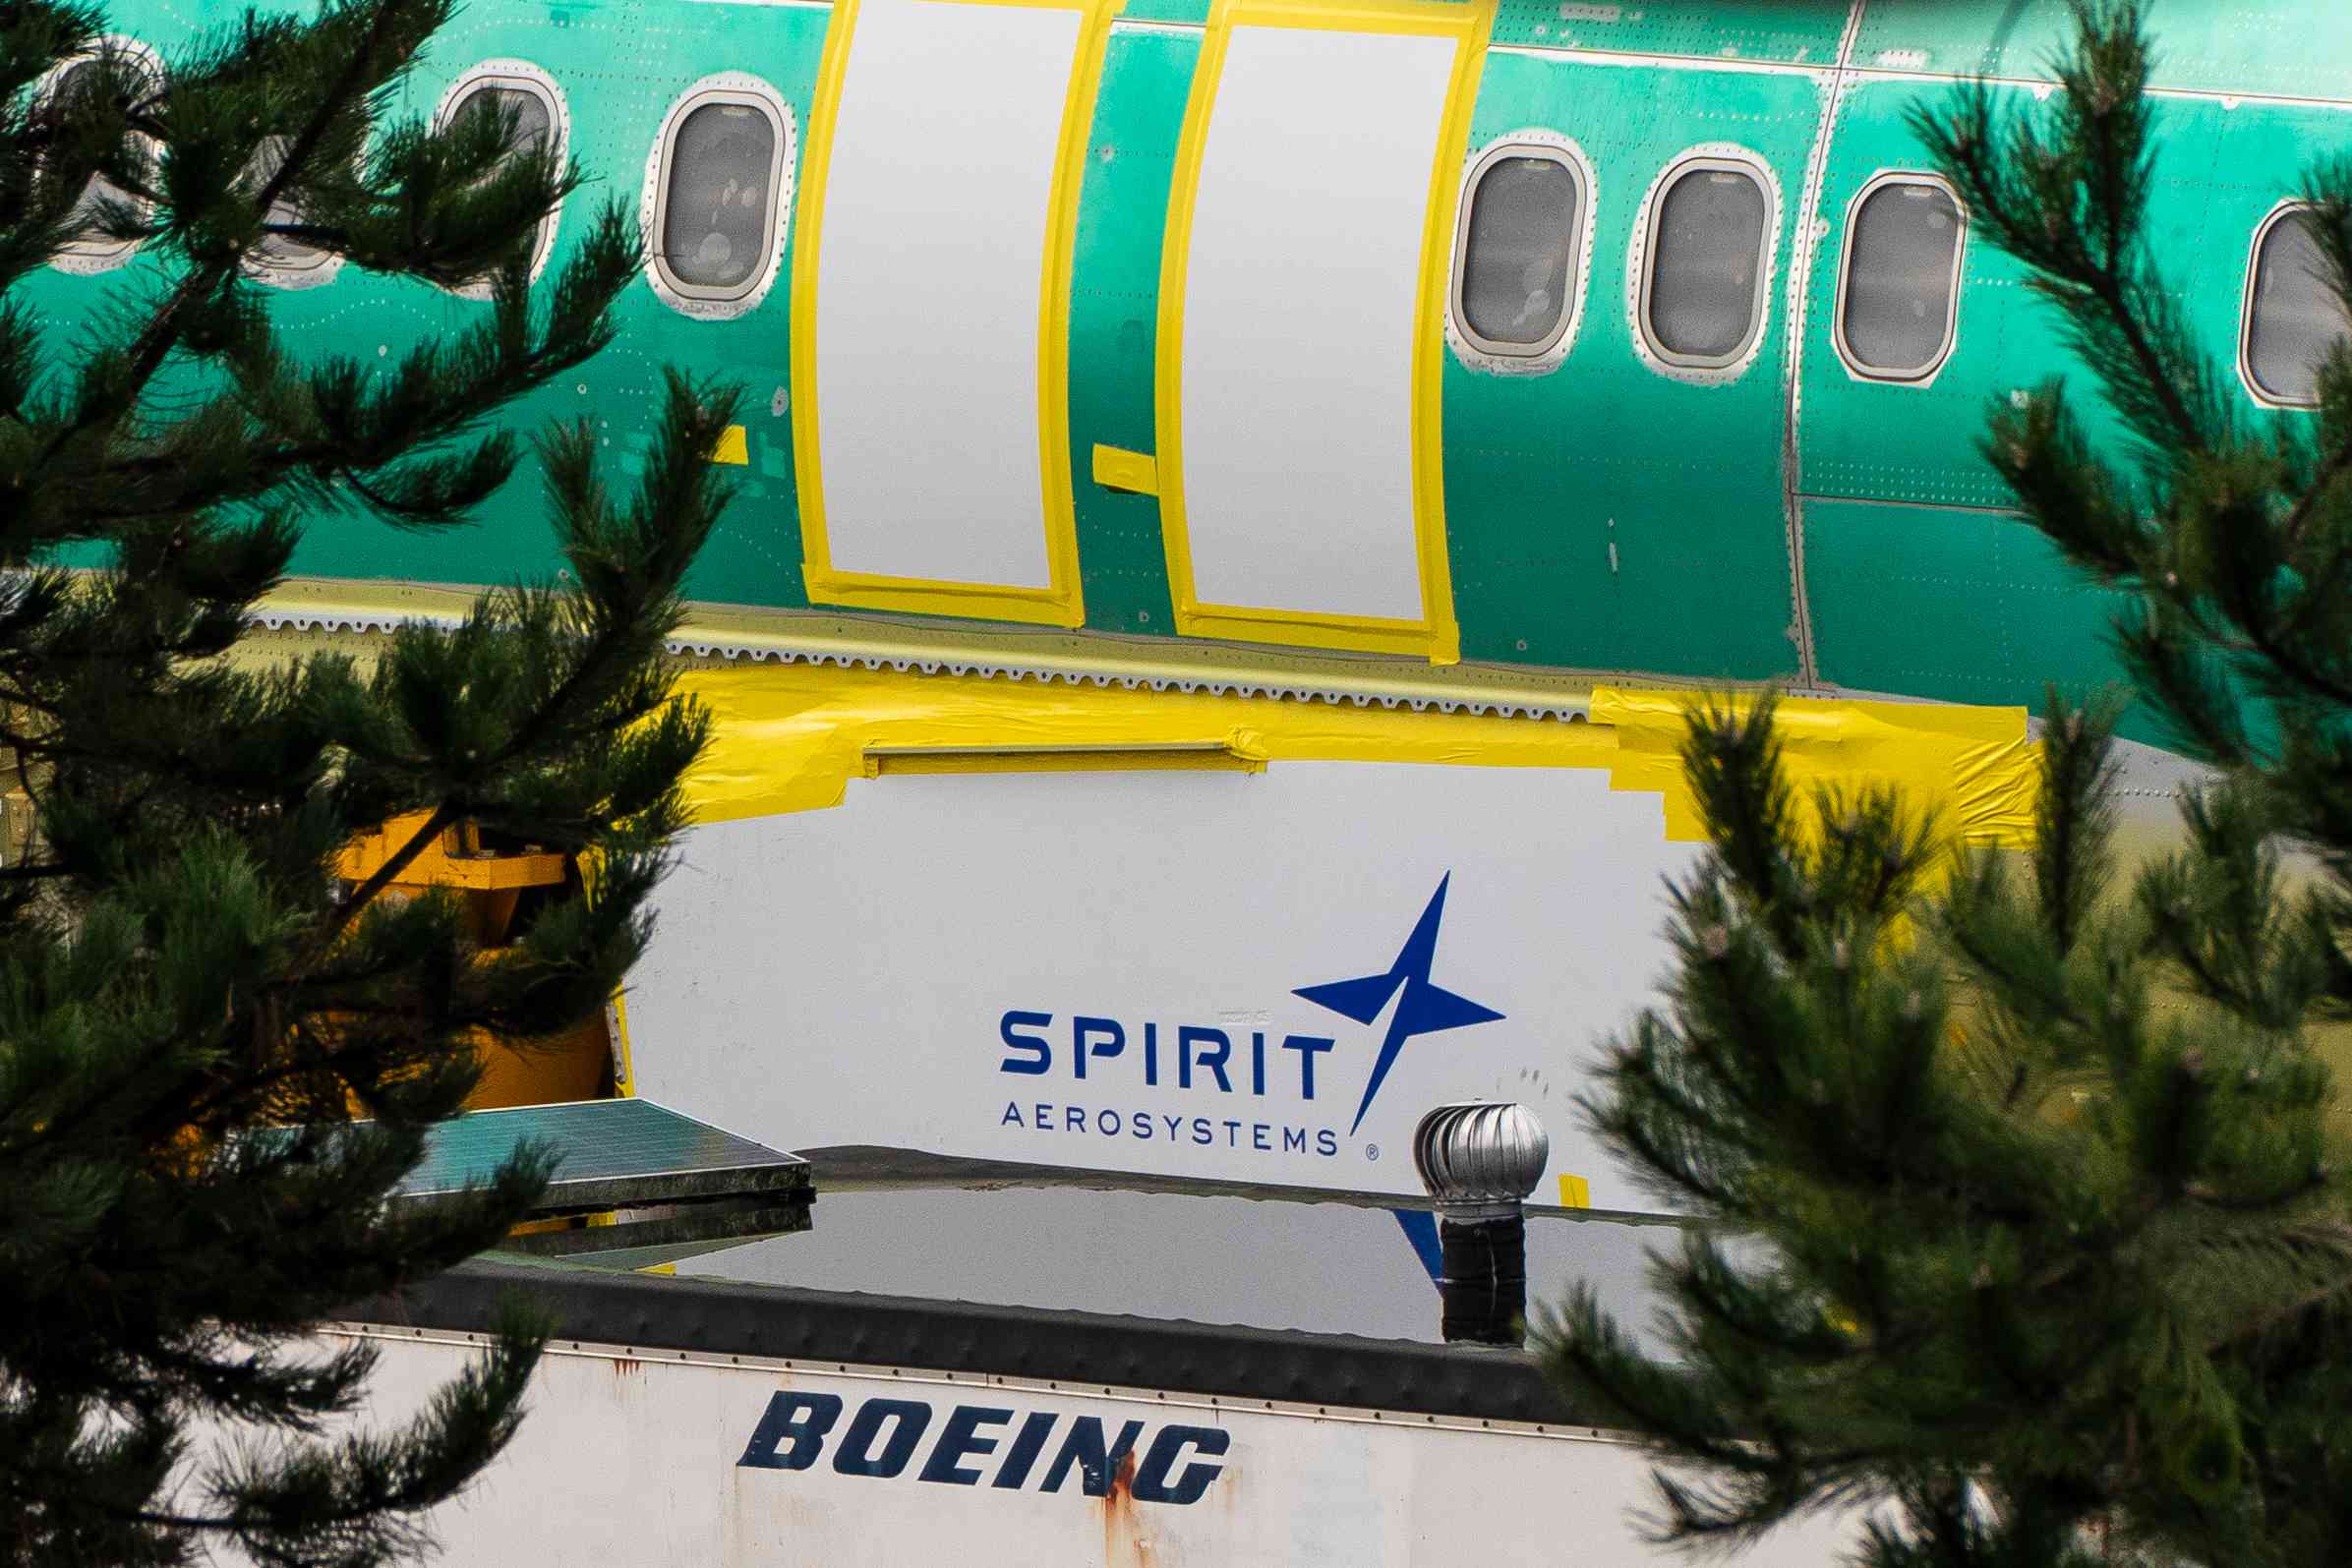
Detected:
[1543,0,2352,1568]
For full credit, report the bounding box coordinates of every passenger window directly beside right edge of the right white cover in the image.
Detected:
[1453,145,1585,360]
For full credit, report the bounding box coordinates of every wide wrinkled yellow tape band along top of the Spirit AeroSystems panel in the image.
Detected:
[677,666,2036,846]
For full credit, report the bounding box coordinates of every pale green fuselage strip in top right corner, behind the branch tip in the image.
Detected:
[1853,0,2352,98]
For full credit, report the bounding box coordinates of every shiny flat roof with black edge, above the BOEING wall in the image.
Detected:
[357,1100,1673,1427]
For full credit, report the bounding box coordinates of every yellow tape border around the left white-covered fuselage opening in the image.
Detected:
[791,0,1124,625]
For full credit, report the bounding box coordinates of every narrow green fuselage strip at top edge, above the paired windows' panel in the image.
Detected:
[1494,0,1847,66]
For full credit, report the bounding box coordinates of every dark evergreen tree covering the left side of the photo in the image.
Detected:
[0,0,736,1563]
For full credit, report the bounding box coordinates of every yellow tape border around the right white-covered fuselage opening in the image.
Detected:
[1154,0,1496,663]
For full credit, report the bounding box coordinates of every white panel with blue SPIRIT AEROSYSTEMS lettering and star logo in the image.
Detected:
[628,762,1693,1208]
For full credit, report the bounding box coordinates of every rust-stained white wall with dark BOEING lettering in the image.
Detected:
[270,1330,1852,1568]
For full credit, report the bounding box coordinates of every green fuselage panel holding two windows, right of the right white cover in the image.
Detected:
[1444,54,1820,679]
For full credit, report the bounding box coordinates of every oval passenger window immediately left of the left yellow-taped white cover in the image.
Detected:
[654,94,781,299]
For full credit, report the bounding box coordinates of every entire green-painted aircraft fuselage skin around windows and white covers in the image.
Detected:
[24,0,2352,724]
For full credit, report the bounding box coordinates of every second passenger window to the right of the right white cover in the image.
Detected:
[1642,160,1771,369]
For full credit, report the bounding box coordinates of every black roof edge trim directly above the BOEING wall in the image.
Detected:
[336,1262,1602,1427]
